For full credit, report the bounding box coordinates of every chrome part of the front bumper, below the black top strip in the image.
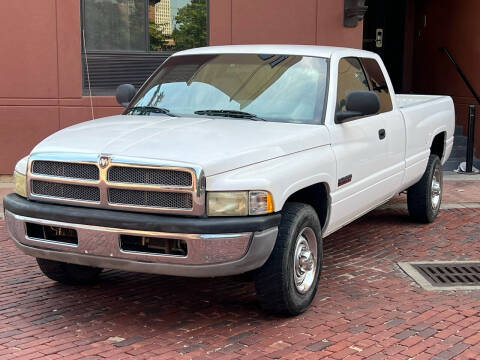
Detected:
[5,210,278,277]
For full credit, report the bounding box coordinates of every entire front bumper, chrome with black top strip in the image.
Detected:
[4,194,280,277]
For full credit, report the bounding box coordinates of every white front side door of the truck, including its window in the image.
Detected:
[327,57,394,230]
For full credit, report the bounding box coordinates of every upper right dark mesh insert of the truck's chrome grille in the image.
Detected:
[107,166,192,187]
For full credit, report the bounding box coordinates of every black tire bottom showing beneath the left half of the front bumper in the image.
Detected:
[37,258,102,285]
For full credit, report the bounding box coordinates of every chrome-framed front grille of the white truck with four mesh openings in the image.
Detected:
[28,154,205,215]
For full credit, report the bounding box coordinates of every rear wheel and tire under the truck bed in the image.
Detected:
[407,155,443,223]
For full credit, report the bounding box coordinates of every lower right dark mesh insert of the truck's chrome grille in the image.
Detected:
[108,188,193,209]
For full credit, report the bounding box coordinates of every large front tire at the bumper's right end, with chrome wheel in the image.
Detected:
[255,202,323,315]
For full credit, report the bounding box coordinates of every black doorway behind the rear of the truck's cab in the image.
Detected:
[363,0,407,92]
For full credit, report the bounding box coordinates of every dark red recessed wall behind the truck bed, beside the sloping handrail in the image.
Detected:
[411,0,480,152]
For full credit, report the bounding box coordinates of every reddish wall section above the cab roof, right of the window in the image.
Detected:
[210,0,362,48]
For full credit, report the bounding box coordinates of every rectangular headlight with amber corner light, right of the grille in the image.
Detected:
[207,191,273,216]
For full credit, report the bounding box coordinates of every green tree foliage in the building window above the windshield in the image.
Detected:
[172,0,207,50]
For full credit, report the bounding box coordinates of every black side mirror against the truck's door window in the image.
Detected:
[335,90,380,124]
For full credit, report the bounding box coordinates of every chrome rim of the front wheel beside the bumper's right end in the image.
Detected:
[293,227,317,294]
